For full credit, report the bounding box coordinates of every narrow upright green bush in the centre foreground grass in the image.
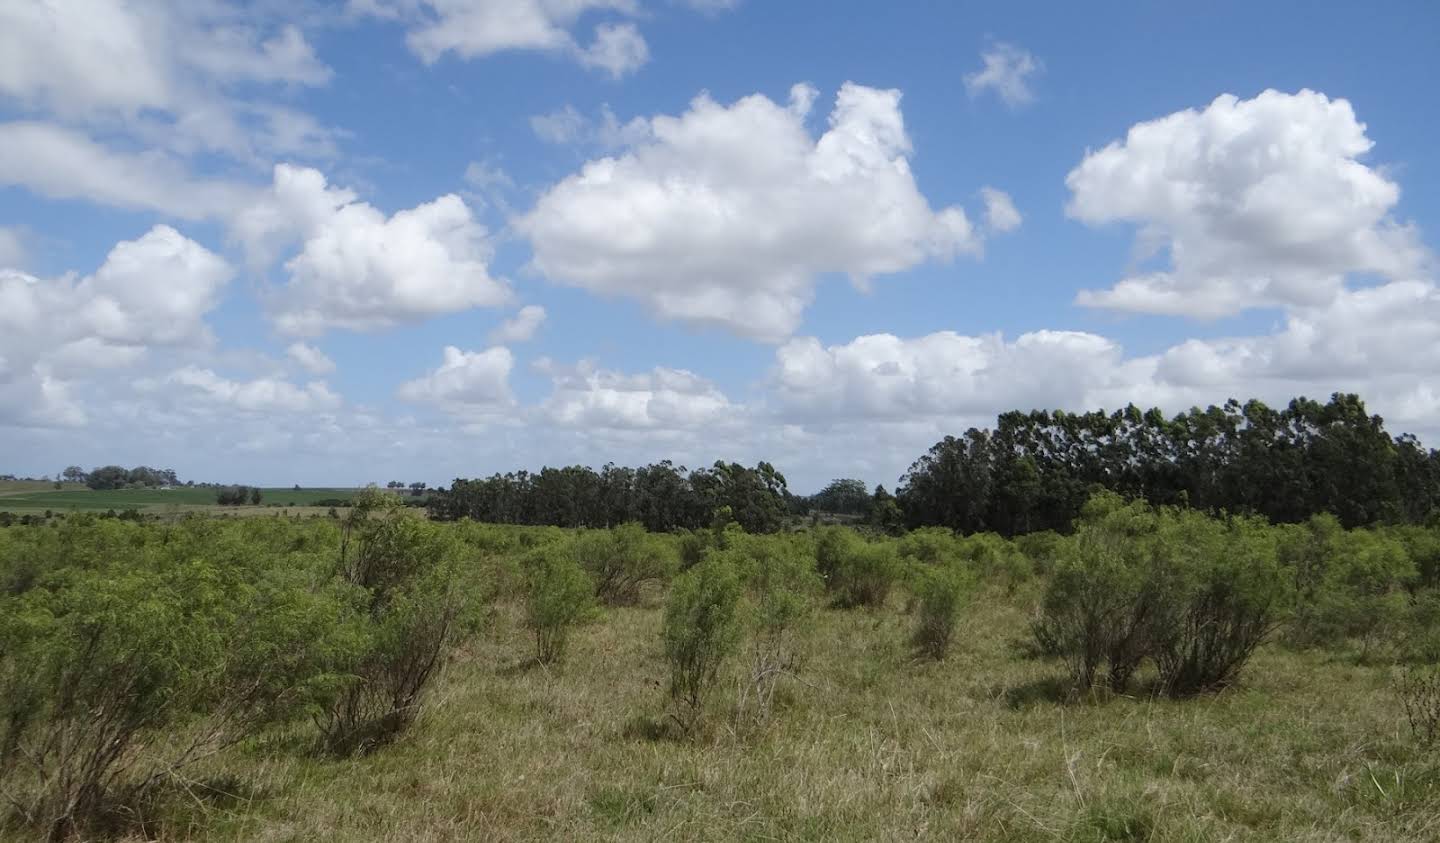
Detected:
[664,555,742,732]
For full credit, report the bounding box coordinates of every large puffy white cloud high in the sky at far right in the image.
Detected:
[1066,91,1427,317]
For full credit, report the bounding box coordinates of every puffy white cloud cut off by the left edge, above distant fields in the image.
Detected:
[0,226,233,425]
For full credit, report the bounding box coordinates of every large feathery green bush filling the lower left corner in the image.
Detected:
[0,519,353,837]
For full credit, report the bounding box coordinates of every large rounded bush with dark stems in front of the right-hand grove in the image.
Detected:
[1032,493,1290,697]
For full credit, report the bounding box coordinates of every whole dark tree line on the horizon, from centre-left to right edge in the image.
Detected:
[429,393,1440,536]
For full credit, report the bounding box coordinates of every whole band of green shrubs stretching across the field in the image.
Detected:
[0,481,1440,837]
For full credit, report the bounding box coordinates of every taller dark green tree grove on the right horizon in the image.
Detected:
[897,393,1440,535]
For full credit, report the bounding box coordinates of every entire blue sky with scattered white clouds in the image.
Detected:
[0,0,1440,493]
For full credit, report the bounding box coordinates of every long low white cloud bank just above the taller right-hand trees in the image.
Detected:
[769,272,1440,447]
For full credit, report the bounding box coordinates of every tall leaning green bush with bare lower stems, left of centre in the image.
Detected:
[318,490,480,755]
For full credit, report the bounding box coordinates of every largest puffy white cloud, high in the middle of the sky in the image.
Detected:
[517,84,1008,342]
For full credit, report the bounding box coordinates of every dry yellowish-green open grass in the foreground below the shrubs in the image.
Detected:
[129,589,1440,842]
